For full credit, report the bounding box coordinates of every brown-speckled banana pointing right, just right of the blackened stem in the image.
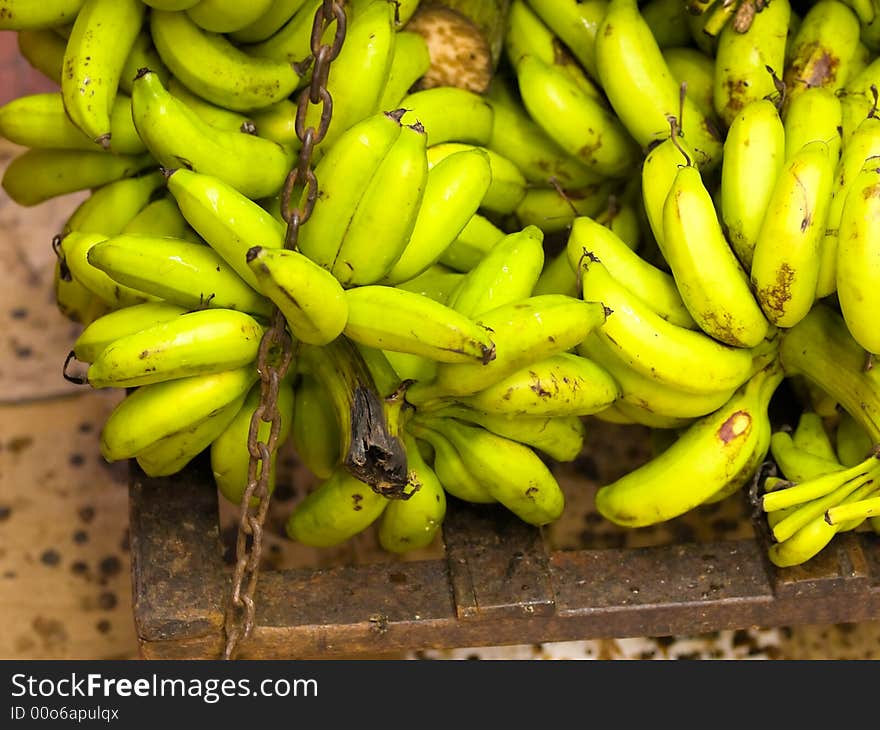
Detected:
[460,352,621,417]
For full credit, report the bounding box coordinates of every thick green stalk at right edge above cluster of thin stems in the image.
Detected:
[779,302,880,443]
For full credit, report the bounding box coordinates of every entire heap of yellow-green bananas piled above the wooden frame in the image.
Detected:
[0,0,880,565]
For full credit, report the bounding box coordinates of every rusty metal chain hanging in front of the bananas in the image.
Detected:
[223,0,346,659]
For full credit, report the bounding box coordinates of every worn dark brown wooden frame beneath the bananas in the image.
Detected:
[130,450,880,659]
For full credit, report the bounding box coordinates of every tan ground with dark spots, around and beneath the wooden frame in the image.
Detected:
[0,132,880,660]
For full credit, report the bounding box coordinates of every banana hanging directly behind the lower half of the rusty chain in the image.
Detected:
[210,377,296,505]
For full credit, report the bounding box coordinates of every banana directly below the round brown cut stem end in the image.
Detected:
[400,86,492,147]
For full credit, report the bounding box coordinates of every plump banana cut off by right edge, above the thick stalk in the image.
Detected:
[837,159,880,353]
